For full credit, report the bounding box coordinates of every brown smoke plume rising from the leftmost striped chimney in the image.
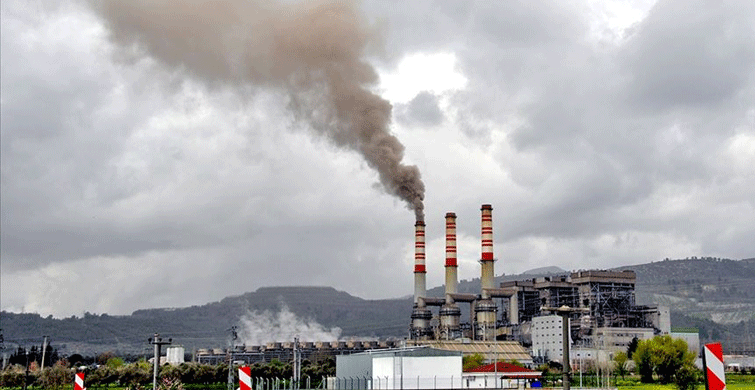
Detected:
[91,0,425,220]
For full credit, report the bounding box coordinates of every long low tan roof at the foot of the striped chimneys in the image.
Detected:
[407,340,532,362]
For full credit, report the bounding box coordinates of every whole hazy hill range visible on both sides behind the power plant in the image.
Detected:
[0,259,755,354]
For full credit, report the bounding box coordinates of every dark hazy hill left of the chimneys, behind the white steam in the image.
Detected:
[0,287,412,353]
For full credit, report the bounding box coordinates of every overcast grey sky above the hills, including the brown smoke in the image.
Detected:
[0,0,755,316]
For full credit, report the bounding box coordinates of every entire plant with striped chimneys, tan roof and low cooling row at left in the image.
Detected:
[197,204,688,376]
